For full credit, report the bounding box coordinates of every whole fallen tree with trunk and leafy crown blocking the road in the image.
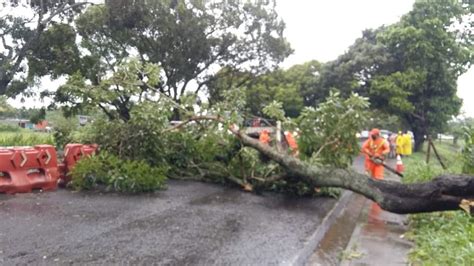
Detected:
[62,62,474,213]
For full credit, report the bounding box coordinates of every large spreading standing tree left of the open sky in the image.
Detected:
[27,0,291,118]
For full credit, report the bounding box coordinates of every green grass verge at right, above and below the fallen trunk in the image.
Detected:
[403,142,474,265]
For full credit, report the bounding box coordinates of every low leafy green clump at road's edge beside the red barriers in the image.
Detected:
[70,152,167,193]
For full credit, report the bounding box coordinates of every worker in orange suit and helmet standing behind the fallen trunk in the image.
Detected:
[362,128,390,180]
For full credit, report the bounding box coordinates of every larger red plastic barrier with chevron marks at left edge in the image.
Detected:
[0,145,59,194]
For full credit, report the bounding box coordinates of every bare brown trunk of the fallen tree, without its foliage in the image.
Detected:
[231,124,474,214]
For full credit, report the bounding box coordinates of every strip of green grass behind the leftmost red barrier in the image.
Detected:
[0,130,54,147]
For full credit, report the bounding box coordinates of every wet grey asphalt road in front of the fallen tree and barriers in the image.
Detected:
[0,181,336,265]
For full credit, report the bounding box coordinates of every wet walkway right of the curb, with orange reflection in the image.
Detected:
[307,157,412,265]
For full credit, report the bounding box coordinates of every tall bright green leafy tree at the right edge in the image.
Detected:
[370,1,473,150]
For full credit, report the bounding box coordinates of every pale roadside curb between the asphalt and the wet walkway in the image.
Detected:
[285,190,353,265]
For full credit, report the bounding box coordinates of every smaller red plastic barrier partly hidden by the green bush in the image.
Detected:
[59,143,98,185]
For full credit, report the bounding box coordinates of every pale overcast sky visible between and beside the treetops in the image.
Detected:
[4,0,474,117]
